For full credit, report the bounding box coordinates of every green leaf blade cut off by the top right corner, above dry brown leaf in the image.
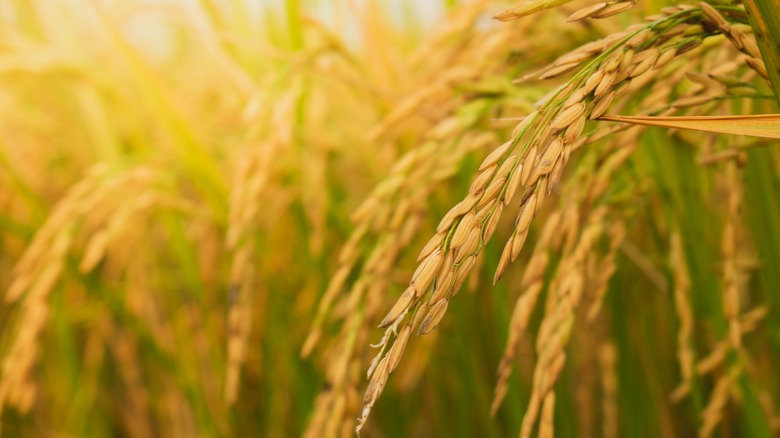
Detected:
[744,0,780,105]
